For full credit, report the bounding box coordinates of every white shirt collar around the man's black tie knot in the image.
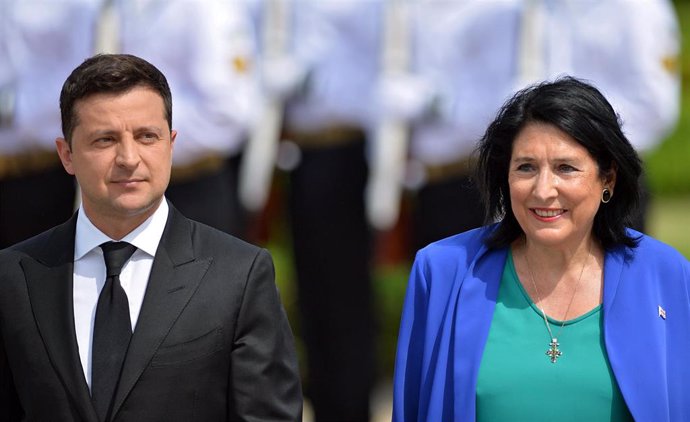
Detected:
[74,198,170,261]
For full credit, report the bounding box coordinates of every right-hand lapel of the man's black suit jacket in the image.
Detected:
[112,206,211,419]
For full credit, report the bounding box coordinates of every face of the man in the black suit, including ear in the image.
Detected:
[56,87,177,234]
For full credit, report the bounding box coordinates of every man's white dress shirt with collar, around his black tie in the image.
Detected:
[73,199,169,387]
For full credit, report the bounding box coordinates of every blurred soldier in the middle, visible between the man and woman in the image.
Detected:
[247,0,381,422]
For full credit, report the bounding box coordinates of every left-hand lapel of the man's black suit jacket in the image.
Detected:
[21,214,98,421]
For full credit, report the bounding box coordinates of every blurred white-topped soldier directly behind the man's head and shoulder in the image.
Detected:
[106,0,257,236]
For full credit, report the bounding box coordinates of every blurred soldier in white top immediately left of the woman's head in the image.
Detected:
[378,0,517,250]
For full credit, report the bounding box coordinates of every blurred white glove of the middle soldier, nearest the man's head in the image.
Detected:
[262,56,307,100]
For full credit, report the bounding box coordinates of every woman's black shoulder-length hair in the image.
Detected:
[476,76,642,248]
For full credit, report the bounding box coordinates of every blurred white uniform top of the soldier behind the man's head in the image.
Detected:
[116,0,256,166]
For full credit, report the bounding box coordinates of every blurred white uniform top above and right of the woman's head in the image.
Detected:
[518,0,680,151]
